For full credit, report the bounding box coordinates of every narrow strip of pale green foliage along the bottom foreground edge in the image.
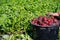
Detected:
[2,34,32,40]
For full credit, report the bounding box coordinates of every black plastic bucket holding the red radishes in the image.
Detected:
[32,21,59,40]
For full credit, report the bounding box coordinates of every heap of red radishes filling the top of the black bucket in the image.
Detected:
[31,16,59,27]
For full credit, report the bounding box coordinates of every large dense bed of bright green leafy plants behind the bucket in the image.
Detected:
[0,0,60,33]
